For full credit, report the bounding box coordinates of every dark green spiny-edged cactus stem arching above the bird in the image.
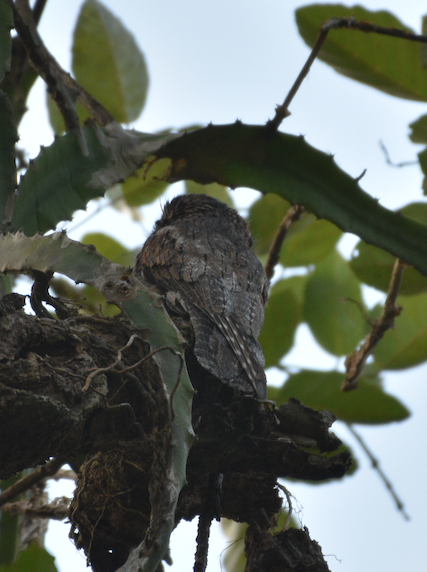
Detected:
[157,123,427,275]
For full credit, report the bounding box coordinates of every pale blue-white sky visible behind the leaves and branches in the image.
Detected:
[17,0,427,572]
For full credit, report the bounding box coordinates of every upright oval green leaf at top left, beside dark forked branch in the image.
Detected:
[72,0,148,123]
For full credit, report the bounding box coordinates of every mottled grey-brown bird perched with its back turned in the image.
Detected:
[135,195,268,399]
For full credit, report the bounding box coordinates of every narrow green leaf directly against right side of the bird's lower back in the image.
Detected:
[259,276,306,367]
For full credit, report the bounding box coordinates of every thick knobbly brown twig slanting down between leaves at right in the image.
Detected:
[341,258,406,391]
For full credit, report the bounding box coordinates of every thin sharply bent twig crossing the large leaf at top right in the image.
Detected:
[267,16,427,130]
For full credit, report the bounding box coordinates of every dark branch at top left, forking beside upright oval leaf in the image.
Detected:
[11,0,114,132]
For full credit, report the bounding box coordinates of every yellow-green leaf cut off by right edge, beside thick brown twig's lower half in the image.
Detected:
[374,294,427,370]
